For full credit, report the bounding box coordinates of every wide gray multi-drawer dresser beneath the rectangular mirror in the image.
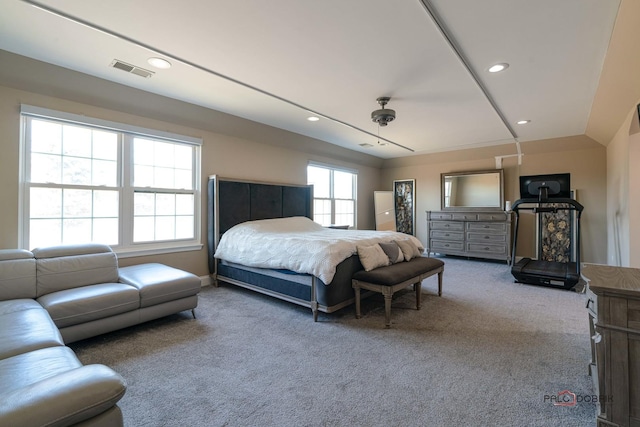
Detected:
[427,210,511,263]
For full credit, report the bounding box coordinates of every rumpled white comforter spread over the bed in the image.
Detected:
[214,217,424,284]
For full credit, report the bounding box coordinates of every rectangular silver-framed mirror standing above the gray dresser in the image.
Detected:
[440,169,504,210]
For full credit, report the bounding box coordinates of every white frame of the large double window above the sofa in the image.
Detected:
[18,104,203,258]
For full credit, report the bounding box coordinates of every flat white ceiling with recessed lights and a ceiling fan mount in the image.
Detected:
[0,0,620,159]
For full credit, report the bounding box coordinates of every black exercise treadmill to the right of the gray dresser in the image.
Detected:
[511,174,584,289]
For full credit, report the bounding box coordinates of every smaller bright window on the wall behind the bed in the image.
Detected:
[307,164,358,227]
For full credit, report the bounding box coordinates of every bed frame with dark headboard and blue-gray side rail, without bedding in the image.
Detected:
[208,175,362,321]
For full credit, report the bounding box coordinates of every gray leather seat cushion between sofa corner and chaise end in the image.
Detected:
[37,283,140,328]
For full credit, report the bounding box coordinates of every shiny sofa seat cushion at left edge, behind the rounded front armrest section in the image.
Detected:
[0,300,64,362]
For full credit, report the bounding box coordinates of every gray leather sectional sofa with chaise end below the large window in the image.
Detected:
[0,244,201,426]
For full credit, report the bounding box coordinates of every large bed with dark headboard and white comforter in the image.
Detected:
[208,175,419,321]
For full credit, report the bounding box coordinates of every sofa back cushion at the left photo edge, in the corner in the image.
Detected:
[0,249,36,301]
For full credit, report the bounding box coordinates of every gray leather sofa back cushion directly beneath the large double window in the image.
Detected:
[33,244,118,297]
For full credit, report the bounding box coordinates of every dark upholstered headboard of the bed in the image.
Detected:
[207,175,313,273]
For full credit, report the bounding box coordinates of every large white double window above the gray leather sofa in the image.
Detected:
[20,105,201,255]
